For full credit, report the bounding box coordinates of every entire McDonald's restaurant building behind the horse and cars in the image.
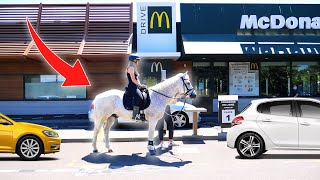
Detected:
[0,2,320,118]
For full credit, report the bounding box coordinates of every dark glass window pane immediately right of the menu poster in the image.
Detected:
[260,62,290,97]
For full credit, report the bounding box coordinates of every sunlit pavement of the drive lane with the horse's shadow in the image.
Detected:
[0,141,320,180]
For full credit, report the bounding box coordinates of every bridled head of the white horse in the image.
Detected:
[178,71,197,99]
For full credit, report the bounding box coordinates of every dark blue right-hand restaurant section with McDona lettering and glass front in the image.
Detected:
[178,3,320,113]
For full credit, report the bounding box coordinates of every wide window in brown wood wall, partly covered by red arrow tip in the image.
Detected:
[24,75,86,100]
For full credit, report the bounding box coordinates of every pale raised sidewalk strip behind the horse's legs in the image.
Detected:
[56,126,228,143]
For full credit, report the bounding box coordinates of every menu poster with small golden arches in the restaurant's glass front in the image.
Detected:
[229,62,259,96]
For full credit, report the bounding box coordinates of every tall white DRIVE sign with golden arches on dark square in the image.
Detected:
[137,2,177,53]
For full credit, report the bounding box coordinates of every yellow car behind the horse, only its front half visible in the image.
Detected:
[0,113,61,161]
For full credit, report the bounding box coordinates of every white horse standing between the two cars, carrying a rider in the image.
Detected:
[90,72,196,153]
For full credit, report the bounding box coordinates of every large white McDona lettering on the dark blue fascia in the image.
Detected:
[240,15,320,29]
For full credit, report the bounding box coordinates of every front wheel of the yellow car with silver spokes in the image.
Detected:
[17,136,43,161]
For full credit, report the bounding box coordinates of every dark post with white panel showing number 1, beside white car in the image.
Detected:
[218,95,238,131]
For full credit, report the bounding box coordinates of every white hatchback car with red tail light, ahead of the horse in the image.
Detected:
[227,98,320,158]
